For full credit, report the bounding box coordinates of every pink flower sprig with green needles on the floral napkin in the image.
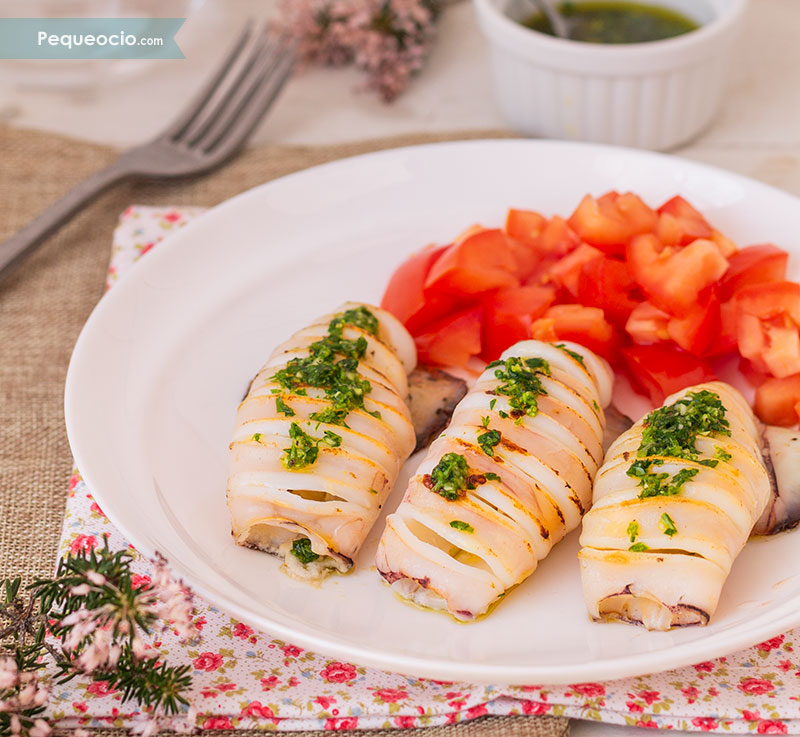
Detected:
[0,541,198,737]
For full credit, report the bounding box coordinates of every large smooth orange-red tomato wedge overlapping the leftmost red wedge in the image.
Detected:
[425,229,519,297]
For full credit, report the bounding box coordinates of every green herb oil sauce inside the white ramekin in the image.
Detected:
[522,2,699,44]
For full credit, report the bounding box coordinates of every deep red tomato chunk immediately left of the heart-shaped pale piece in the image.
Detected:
[577,257,641,326]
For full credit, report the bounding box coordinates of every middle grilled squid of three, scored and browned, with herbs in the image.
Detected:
[376,340,613,621]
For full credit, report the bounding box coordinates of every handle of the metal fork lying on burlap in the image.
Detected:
[0,159,134,280]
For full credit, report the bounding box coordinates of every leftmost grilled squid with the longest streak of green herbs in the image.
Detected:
[227,303,416,580]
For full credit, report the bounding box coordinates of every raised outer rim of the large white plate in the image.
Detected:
[64,138,800,685]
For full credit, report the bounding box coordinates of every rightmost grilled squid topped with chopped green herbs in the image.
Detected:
[579,382,771,630]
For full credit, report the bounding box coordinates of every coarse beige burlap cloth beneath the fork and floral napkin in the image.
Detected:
[0,127,568,737]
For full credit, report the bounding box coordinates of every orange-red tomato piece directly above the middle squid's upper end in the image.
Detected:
[531,304,621,363]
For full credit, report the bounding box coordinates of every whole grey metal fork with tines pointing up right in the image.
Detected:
[0,22,295,279]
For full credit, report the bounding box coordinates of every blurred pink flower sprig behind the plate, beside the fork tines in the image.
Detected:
[278,0,445,102]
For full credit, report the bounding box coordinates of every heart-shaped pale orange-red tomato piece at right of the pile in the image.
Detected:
[627,235,728,317]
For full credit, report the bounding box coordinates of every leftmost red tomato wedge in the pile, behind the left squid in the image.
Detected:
[381,245,454,333]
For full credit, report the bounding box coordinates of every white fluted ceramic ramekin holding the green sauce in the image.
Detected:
[474,0,747,150]
